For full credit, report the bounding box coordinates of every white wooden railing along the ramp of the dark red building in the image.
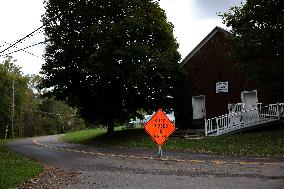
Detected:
[205,103,284,136]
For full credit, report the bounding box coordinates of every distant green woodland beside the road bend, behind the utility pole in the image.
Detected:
[0,57,85,138]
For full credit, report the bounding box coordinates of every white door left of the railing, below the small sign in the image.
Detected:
[192,95,206,119]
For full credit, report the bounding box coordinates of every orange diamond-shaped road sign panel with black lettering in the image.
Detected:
[144,109,176,146]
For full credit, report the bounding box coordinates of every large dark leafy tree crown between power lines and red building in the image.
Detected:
[42,0,180,133]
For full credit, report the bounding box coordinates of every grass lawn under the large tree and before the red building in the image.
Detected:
[61,125,284,157]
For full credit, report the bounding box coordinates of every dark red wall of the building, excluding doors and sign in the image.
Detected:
[175,28,270,128]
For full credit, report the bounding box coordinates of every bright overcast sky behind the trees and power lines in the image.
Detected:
[0,0,244,74]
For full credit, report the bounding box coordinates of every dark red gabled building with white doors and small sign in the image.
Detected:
[175,27,268,128]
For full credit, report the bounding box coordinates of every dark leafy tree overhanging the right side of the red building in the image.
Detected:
[222,0,284,100]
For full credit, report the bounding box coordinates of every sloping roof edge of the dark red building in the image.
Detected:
[180,26,230,66]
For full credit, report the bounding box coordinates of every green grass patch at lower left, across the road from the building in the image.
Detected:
[0,140,43,189]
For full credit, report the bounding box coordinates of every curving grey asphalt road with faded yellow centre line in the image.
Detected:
[8,136,284,189]
